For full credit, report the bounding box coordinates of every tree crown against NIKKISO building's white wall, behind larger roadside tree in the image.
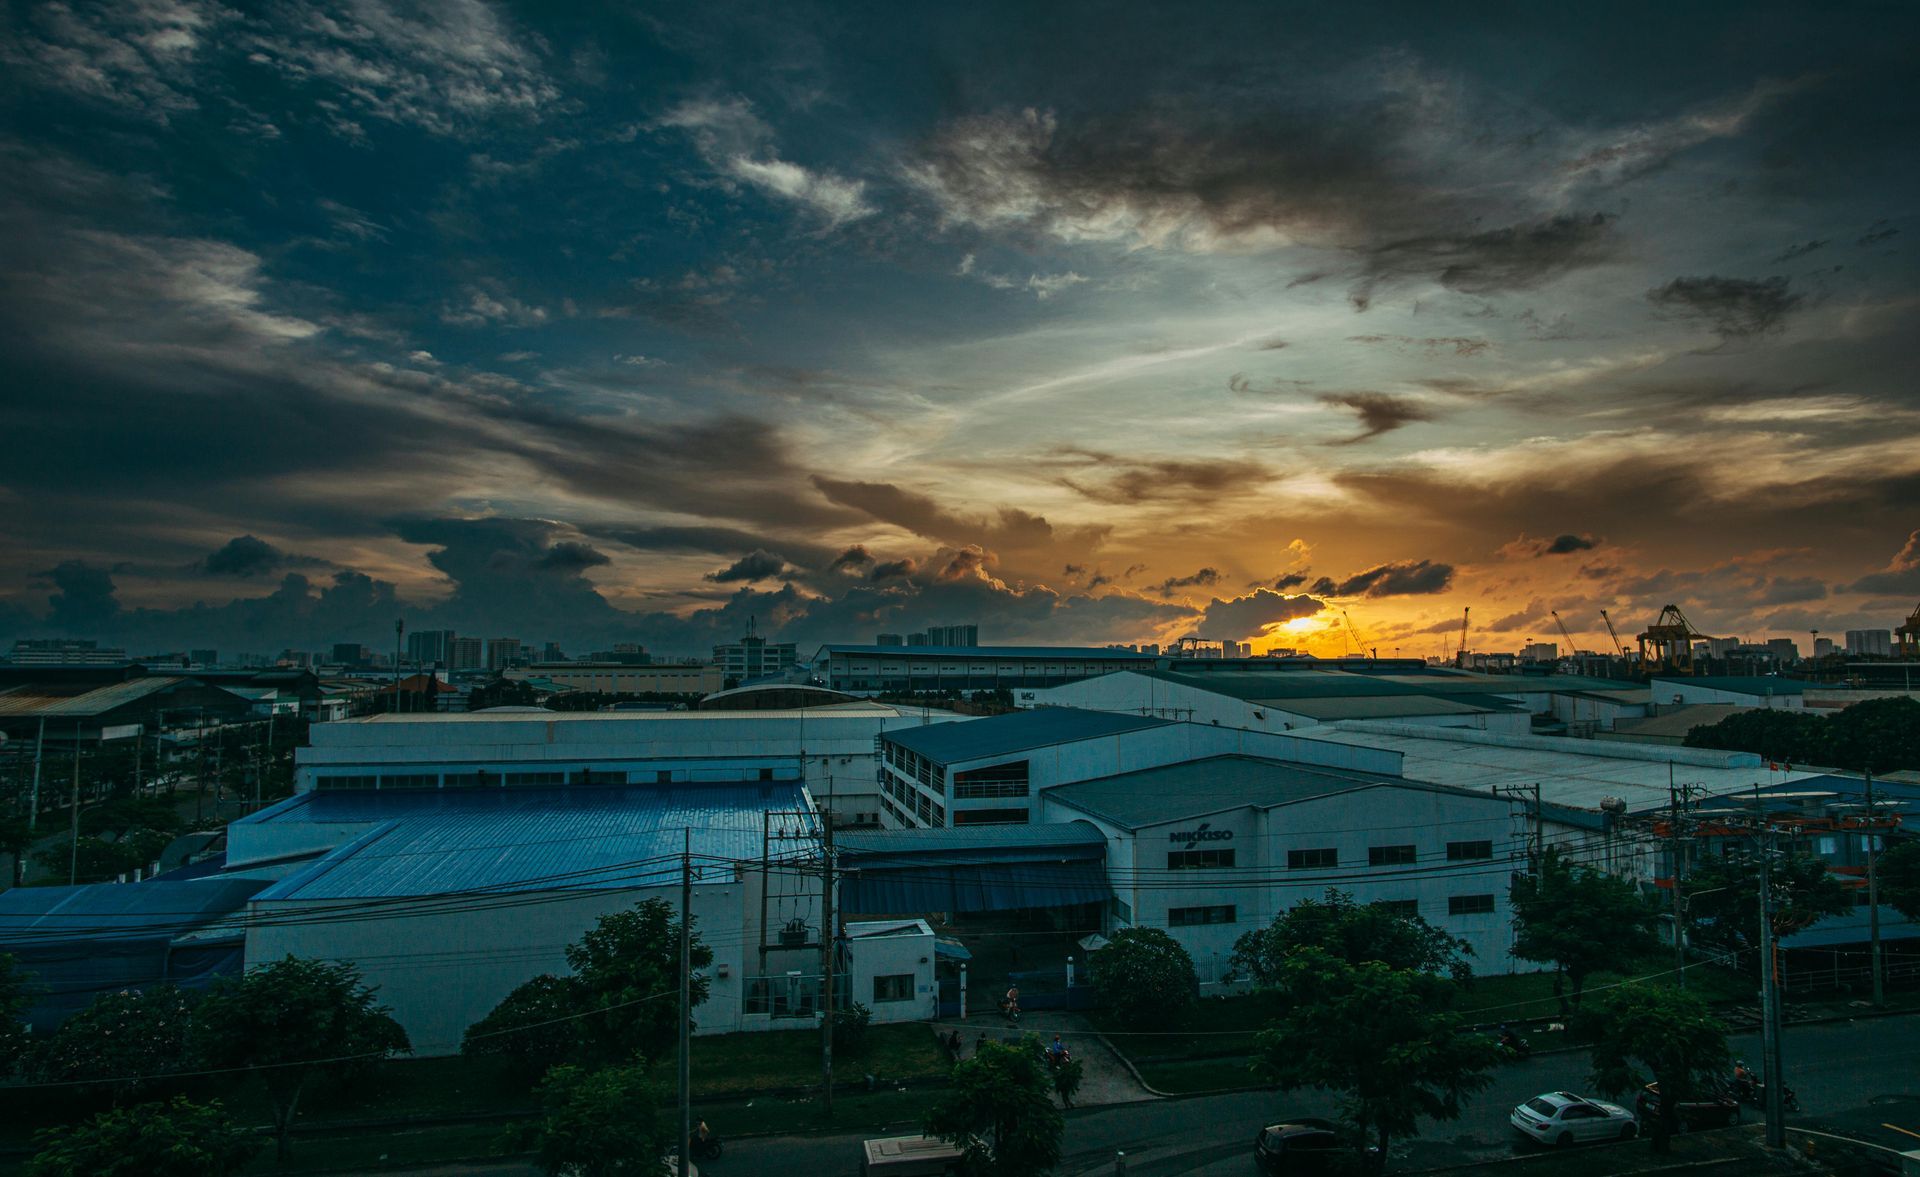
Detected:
[1233,887,1473,985]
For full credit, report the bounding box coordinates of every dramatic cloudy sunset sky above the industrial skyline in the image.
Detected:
[0,0,1920,655]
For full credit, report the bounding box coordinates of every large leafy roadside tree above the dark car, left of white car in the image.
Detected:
[1252,947,1500,1158]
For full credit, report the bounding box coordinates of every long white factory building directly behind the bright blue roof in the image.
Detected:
[294,703,975,826]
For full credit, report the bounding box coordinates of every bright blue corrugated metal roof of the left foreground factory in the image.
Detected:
[255,781,806,901]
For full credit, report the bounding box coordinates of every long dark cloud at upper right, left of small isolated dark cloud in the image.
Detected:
[1352,213,1617,309]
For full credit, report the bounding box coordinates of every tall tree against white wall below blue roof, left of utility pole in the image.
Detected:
[566,899,714,1062]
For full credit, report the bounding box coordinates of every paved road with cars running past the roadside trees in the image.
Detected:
[718,1016,1920,1177]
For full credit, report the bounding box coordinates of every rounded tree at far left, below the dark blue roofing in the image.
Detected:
[36,985,194,1102]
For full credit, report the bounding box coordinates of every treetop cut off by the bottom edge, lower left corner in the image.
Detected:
[27,1096,259,1177]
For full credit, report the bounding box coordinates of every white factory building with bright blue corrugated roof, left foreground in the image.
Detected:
[227,781,822,1056]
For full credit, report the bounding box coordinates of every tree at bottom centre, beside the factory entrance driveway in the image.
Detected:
[927,1035,1066,1177]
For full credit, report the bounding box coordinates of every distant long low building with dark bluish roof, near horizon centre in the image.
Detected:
[812,645,1160,695]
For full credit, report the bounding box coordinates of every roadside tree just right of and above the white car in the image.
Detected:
[1576,985,1728,1152]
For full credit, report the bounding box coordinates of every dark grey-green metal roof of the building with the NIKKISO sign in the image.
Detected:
[1046,757,1425,829]
